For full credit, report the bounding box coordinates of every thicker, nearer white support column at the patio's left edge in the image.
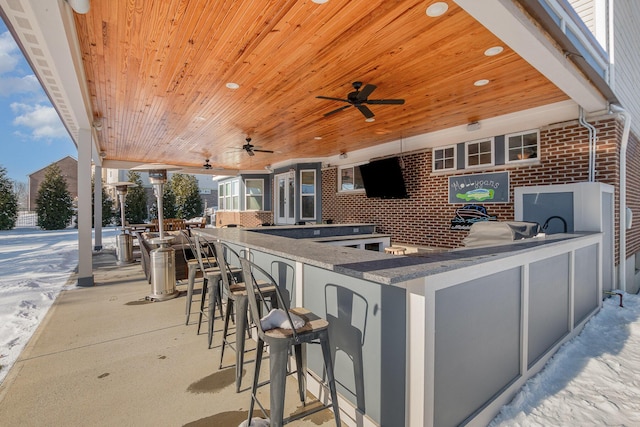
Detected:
[78,129,94,286]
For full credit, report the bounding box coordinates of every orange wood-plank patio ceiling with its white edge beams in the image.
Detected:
[0,0,611,173]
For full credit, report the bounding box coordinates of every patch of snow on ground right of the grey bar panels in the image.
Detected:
[491,294,640,427]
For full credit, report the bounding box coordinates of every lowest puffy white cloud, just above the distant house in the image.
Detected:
[11,102,68,139]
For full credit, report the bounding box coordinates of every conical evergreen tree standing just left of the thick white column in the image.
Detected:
[36,164,73,230]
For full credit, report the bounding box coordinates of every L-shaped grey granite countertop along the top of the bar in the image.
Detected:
[192,228,593,285]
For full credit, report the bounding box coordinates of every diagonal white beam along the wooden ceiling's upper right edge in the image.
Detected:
[454,0,608,112]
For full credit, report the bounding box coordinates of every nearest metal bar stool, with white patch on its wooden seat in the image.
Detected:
[240,258,340,427]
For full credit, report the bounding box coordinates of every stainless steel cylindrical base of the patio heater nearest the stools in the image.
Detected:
[147,239,178,301]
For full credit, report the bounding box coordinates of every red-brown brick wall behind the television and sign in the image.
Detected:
[322,117,640,264]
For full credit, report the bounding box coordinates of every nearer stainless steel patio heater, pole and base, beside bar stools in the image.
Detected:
[146,169,178,301]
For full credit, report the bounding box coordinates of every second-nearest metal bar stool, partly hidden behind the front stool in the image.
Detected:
[213,242,275,392]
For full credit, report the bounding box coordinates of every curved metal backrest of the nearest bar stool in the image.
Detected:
[240,258,298,343]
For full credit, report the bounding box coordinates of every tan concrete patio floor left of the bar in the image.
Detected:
[0,252,335,426]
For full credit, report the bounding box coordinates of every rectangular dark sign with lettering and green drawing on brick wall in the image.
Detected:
[449,172,509,203]
